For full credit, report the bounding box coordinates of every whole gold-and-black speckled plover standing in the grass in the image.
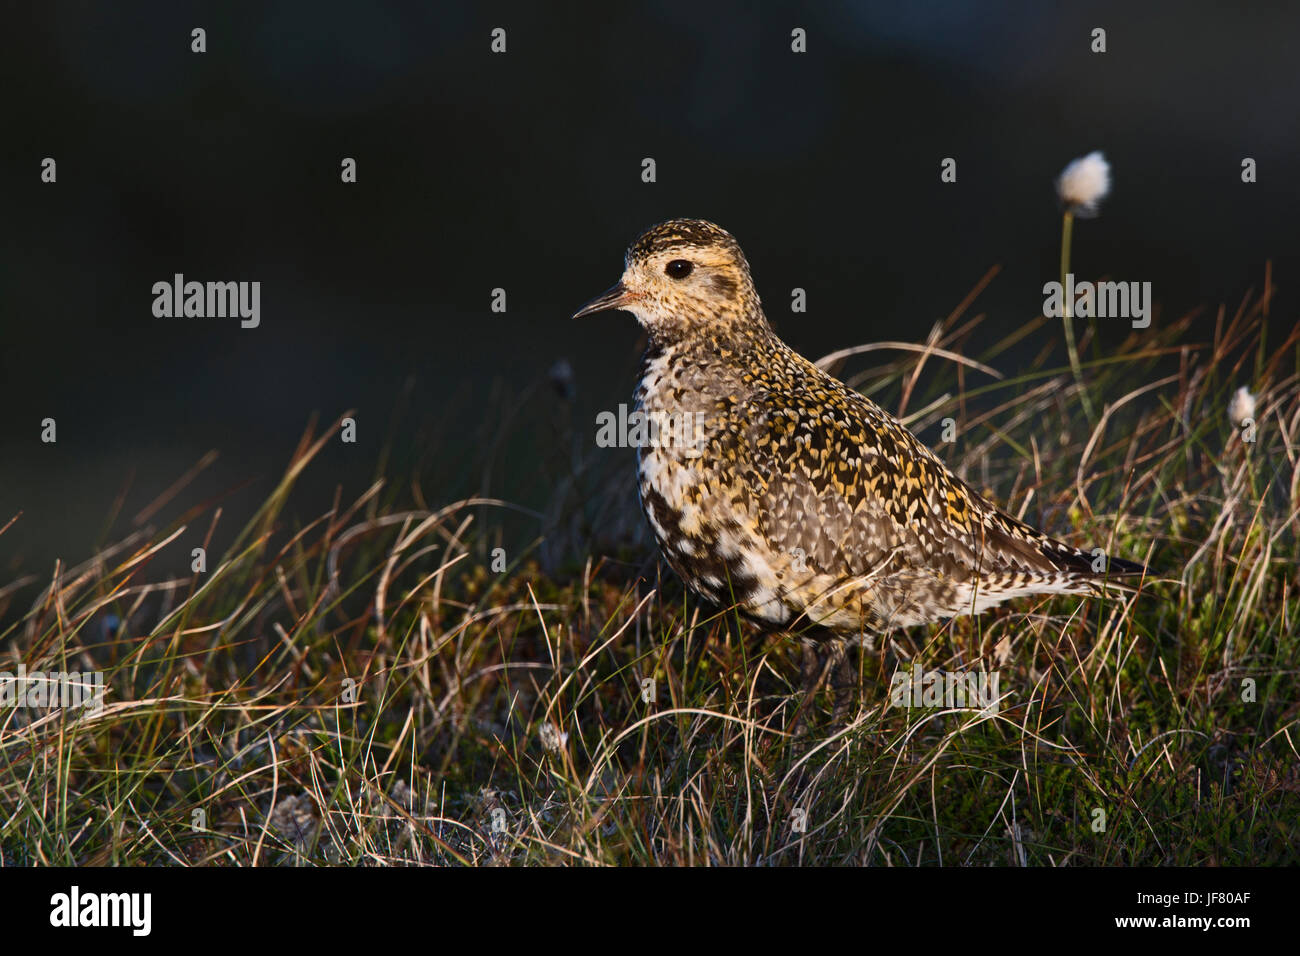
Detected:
[579,220,1143,646]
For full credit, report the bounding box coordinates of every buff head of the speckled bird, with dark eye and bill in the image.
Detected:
[573,219,768,343]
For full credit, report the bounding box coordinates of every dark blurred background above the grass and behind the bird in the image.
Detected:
[0,0,1300,587]
